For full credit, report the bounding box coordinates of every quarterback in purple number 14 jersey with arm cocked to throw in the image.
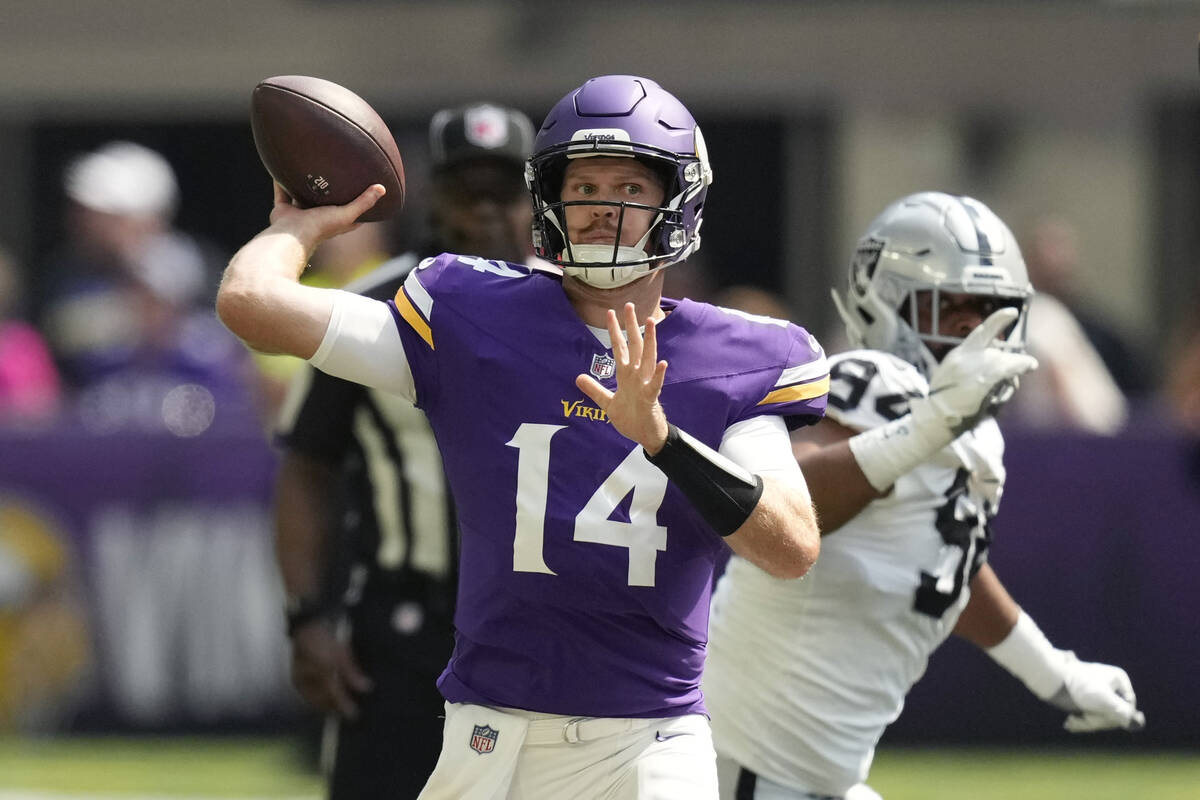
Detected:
[217,76,829,800]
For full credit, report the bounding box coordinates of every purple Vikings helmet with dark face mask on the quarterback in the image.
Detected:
[526,76,713,288]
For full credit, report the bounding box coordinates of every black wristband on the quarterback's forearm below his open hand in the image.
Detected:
[642,425,762,536]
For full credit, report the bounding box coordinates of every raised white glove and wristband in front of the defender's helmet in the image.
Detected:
[850,308,1038,492]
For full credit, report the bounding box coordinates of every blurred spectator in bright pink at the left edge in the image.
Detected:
[0,249,59,425]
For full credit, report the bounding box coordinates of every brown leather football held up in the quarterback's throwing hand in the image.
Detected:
[250,76,404,222]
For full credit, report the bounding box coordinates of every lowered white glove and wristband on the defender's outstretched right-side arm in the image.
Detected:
[988,610,1146,733]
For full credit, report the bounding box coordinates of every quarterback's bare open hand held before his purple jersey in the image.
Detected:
[575,302,667,455]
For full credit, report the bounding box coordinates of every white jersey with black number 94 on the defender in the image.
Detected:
[703,350,1004,796]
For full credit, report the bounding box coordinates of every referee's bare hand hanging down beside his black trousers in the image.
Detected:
[292,619,372,720]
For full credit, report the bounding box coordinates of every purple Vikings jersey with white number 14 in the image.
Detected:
[392,254,828,717]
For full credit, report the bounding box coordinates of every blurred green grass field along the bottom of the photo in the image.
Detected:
[0,739,1200,800]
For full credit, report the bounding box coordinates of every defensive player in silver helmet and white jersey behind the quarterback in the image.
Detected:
[703,192,1144,800]
